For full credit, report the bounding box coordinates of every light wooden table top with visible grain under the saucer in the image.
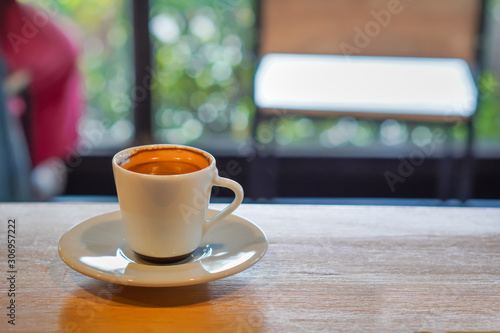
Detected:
[0,204,500,332]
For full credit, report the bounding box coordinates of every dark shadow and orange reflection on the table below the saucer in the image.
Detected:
[51,258,267,332]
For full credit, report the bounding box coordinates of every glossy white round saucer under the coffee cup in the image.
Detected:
[59,209,267,287]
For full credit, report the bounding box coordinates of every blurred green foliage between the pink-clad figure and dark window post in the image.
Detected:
[22,0,133,142]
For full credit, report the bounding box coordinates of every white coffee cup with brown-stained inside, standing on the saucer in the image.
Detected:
[113,144,243,262]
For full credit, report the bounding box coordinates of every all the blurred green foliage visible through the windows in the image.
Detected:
[18,0,500,148]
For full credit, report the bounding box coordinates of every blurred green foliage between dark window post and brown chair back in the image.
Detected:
[150,0,255,143]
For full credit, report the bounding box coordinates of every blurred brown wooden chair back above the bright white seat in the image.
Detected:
[259,0,480,65]
